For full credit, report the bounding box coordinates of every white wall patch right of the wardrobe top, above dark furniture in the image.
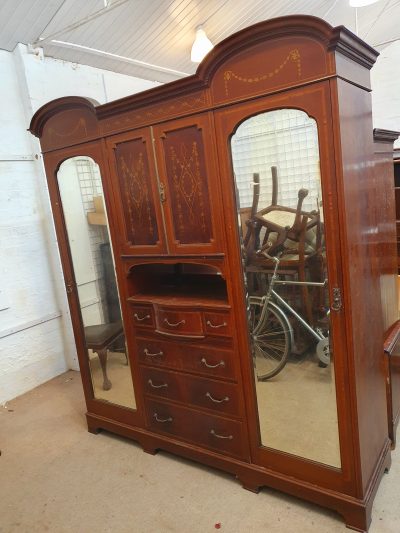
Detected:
[371,41,400,148]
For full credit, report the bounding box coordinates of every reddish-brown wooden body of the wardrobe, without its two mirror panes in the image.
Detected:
[30,16,391,531]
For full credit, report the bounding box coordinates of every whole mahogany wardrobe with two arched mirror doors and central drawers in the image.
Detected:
[30,16,396,531]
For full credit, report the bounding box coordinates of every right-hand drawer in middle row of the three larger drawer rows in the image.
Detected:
[185,376,241,416]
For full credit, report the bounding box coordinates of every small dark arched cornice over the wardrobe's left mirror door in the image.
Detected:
[29,96,99,137]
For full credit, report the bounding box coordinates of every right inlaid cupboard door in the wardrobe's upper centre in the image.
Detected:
[154,113,222,254]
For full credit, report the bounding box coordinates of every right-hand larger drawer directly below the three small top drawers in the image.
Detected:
[180,345,235,379]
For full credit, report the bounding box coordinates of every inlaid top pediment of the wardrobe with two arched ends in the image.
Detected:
[29,15,378,145]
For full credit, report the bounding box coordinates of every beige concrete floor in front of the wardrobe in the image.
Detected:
[0,372,400,533]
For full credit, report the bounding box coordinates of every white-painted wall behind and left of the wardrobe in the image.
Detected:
[0,45,156,404]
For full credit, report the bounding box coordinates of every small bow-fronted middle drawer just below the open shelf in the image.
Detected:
[157,307,204,337]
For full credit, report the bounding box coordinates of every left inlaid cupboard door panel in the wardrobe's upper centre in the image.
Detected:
[107,129,166,254]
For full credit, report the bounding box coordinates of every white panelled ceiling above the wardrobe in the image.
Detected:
[0,0,400,82]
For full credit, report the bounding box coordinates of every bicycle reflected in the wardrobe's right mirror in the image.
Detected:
[249,250,330,381]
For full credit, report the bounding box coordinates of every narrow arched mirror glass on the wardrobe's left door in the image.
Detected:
[57,156,136,409]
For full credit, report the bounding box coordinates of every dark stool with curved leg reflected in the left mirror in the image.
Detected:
[84,321,124,390]
